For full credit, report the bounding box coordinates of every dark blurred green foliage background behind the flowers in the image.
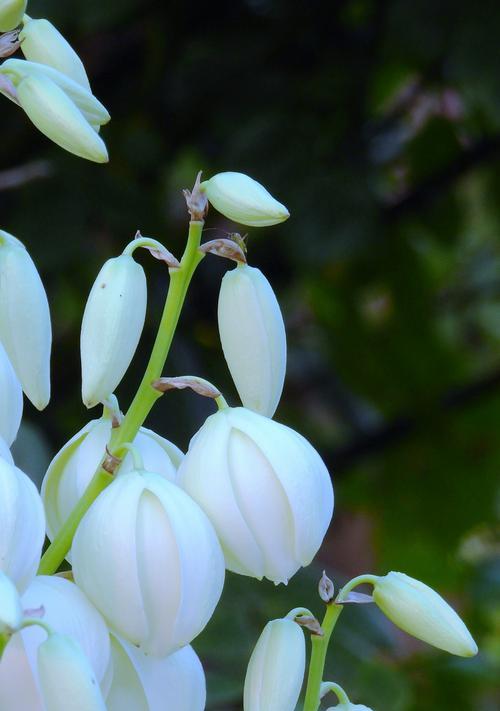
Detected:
[0,0,500,711]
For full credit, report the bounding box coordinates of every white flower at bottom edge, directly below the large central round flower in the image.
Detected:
[106,635,206,711]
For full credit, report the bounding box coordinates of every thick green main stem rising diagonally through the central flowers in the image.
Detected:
[38,221,204,575]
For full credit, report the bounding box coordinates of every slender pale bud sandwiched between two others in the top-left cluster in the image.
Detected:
[0,58,110,130]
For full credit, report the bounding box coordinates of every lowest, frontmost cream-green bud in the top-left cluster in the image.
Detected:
[16,74,108,163]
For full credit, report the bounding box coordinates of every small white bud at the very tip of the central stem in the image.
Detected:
[201,172,290,227]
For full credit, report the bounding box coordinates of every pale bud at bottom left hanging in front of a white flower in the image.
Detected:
[38,634,106,711]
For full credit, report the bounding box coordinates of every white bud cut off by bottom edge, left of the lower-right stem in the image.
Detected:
[243,618,306,711]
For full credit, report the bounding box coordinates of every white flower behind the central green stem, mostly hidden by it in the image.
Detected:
[42,415,184,552]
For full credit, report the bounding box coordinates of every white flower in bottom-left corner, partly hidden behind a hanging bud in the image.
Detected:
[0,576,110,711]
